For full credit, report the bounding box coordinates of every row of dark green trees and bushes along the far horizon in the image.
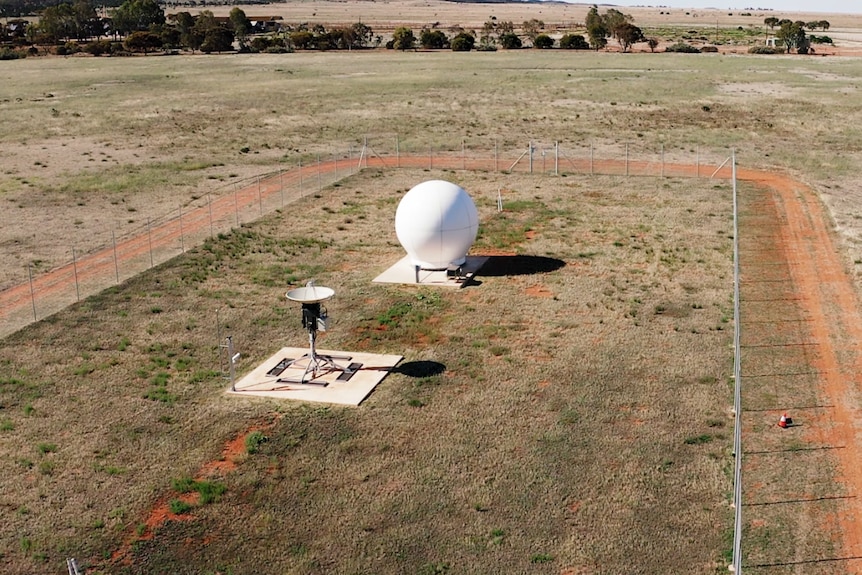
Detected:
[0,0,831,55]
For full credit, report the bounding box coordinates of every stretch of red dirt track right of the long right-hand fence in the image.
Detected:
[738,170,862,573]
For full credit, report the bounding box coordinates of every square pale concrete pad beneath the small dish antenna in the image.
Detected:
[227,347,404,405]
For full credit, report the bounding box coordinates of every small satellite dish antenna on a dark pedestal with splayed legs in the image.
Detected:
[278,280,350,386]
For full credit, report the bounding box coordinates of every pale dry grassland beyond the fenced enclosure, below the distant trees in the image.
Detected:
[5,50,860,286]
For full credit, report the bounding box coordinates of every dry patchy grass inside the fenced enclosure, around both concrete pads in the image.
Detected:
[0,170,730,573]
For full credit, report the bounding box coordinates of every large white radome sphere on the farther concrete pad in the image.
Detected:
[395,180,479,270]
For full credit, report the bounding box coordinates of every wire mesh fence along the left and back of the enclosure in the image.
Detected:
[0,135,730,337]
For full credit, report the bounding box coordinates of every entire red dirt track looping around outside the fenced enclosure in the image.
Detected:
[0,155,862,572]
